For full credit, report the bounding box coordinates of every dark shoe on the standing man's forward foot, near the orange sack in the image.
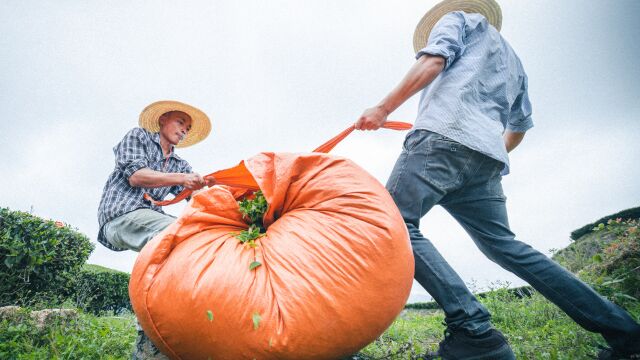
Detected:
[424,329,516,360]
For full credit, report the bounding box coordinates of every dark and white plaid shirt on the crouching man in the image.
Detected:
[98,128,192,251]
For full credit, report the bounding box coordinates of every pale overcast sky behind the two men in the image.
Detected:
[0,0,640,301]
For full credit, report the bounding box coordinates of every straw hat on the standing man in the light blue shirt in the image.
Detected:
[413,0,502,53]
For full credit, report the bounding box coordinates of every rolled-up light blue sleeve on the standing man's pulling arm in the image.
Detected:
[416,11,465,71]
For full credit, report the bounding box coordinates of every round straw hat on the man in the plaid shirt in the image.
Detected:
[138,100,211,148]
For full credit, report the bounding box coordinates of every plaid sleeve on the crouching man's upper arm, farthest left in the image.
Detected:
[113,128,149,180]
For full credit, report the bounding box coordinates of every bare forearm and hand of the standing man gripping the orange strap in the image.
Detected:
[355,54,445,130]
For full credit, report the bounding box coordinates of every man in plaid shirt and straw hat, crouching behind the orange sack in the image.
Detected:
[98,101,214,359]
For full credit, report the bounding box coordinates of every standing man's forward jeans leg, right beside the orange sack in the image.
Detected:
[387,130,491,334]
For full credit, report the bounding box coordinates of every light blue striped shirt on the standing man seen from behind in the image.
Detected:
[414,11,533,175]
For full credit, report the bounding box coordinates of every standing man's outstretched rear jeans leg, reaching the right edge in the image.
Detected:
[442,170,640,351]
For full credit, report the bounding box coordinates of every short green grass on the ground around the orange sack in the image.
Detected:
[0,288,640,360]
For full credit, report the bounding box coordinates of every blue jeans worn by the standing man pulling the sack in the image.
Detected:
[387,130,640,348]
